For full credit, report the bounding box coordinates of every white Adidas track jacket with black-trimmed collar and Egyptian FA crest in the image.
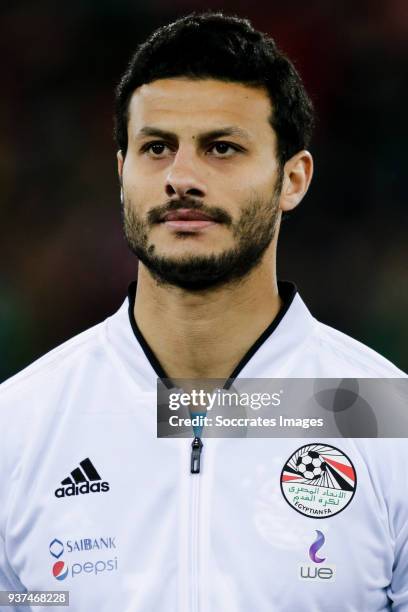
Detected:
[0,283,408,612]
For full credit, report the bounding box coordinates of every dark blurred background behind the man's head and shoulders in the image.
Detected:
[0,0,408,380]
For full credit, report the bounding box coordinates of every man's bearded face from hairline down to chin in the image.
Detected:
[119,78,281,290]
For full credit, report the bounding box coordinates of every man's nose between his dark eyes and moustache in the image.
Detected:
[165,149,207,199]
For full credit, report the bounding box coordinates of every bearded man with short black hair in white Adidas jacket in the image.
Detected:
[0,14,408,612]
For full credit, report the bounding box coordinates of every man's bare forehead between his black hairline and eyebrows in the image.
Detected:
[129,78,272,132]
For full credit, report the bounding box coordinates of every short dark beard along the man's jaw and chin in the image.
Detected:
[123,181,280,291]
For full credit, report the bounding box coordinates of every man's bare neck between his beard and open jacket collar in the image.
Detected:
[134,251,282,379]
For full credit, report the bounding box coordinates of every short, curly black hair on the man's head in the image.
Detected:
[115,12,314,166]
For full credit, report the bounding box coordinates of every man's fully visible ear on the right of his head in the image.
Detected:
[279,151,313,212]
